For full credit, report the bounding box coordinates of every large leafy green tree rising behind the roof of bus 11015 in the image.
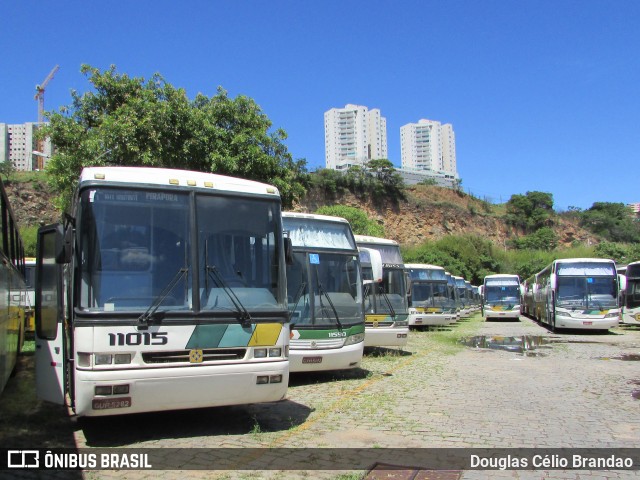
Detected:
[39,65,308,208]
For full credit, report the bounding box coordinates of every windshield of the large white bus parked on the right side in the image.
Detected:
[557,276,618,310]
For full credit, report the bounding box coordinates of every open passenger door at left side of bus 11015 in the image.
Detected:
[35,225,66,404]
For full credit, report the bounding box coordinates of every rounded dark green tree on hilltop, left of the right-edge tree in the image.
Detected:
[506,191,554,233]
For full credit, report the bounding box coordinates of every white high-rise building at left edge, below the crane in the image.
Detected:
[0,122,52,171]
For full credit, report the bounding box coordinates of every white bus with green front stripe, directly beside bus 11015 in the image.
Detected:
[282,212,365,372]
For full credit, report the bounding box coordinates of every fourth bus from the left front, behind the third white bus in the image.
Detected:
[405,263,456,326]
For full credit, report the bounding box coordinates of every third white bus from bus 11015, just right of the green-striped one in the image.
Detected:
[355,235,409,347]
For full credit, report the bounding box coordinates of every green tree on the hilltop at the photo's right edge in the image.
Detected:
[580,202,640,243]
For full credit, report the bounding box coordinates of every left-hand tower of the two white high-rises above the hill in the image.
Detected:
[324,104,388,170]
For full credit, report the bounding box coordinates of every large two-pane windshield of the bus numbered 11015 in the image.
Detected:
[77,187,279,312]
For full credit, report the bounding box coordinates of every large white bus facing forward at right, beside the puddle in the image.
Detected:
[534,258,620,331]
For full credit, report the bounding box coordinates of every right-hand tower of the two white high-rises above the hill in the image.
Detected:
[400,119,457,176]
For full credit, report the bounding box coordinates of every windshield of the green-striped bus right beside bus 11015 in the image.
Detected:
[287,252,363,328]
